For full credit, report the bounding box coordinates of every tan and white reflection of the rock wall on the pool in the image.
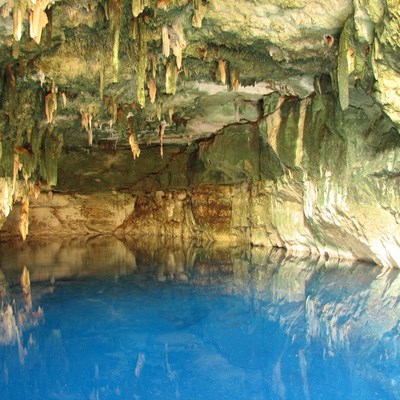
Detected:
[0,236,400,393]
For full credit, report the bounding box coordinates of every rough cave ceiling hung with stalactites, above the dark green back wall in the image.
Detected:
[0,0,353,146]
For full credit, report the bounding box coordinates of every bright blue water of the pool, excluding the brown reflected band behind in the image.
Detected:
[0,239,400,400]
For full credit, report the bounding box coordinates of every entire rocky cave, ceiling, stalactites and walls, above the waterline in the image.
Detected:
[0,0,400,267]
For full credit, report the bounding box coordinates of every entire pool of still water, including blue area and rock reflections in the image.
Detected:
[0,237,400,400]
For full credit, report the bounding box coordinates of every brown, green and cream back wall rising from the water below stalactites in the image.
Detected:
[2,90,400,265]
